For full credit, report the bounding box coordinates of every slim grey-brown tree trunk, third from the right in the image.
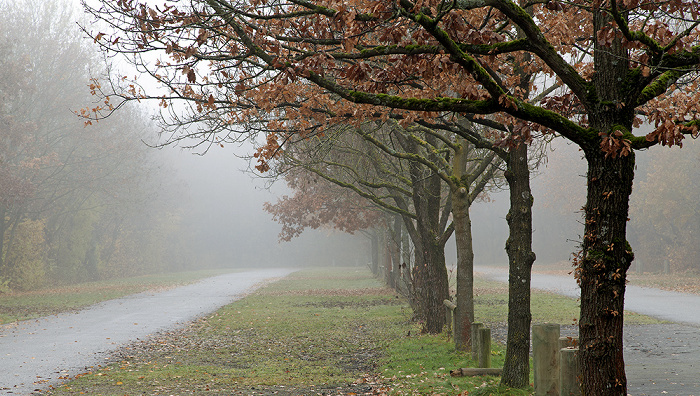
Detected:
[452,183,474,350]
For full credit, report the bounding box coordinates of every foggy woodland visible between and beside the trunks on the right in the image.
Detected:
[468,136,700,272]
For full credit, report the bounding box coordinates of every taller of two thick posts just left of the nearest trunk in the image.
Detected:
[532,323,560,396]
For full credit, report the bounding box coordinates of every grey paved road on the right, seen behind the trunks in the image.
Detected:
[474,266,700,396]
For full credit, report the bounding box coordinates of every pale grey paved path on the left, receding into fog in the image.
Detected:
[0,269,292,395]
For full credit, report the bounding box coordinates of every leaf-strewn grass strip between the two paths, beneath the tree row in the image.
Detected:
[48,268,660,396]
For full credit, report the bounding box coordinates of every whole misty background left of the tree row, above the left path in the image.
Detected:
[0,0,369,292]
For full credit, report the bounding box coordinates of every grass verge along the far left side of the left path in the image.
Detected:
[0,269,233,324]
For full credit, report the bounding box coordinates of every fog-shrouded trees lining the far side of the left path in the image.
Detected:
[0,0,187,291]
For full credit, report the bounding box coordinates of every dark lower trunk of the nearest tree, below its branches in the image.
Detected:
[579,148,634,396]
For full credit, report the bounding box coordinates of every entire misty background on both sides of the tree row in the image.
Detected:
[0,0,700,290]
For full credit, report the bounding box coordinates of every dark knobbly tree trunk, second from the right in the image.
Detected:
[501,143,535,388]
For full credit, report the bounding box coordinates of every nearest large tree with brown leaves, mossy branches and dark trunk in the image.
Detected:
[84,0,700,395]
